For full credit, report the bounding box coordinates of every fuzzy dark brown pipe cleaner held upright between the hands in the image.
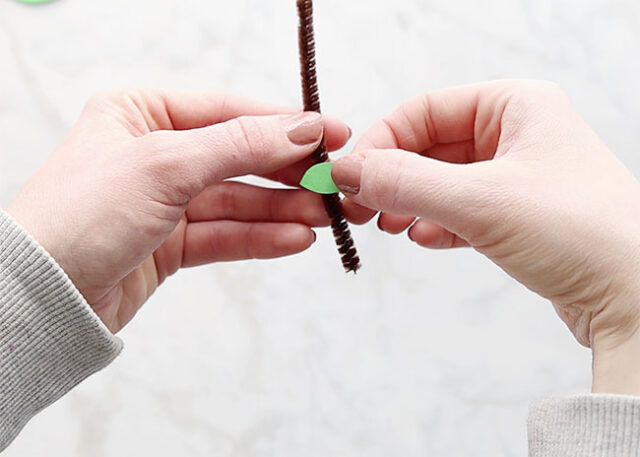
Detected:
[297,0,360,273]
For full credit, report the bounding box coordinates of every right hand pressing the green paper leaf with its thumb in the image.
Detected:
[333,81,640,394]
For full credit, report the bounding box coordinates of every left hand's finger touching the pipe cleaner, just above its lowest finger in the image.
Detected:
[187,181,329,227]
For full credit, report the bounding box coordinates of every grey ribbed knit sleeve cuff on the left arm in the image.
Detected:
[0,210,122,451]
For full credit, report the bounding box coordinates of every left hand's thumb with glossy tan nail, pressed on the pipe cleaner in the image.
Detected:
[141,112,324,195]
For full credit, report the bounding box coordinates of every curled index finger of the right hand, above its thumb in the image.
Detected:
[355,82,515,160]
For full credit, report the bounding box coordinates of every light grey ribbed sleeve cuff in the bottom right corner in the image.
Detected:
[529,394,640,457]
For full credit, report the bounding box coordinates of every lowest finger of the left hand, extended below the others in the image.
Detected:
[182,221,315,267]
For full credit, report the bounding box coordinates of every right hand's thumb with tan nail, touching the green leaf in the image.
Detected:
[332,150,499,234]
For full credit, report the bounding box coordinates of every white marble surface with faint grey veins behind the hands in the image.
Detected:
[0,0,640,457]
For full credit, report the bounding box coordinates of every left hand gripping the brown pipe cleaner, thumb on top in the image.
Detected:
[7,91,350,333]
